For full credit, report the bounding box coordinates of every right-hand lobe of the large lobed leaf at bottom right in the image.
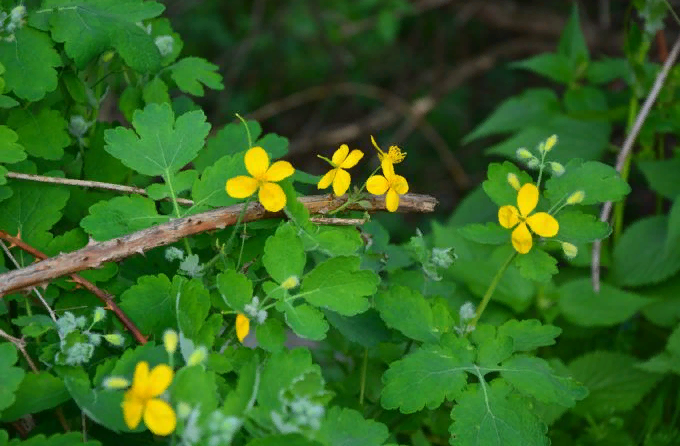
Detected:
[500,355,588,407]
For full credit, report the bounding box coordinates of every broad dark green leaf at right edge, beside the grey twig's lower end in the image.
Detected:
[612,198,680,286]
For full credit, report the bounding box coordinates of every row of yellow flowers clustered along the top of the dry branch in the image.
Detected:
[226,136,408,212]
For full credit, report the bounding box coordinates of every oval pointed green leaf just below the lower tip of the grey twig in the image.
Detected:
[558,278,653,327]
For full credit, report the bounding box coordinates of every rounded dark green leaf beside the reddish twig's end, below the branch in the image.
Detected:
[120,274,177,339]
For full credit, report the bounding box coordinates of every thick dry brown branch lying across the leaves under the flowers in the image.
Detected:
[0,194,437,296]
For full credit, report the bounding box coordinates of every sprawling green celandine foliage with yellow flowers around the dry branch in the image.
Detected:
[0,0,680,446]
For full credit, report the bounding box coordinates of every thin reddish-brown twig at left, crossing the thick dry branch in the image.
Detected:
[0,229,146,345]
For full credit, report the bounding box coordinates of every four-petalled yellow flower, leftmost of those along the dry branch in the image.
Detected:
[226,147,295,212]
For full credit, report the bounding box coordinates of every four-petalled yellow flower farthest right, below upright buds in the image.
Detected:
[498,183,560,254]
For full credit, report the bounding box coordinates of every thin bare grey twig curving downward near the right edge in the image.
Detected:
[591,37,680,292]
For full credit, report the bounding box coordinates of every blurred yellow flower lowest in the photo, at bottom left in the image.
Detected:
[122,361,177,435]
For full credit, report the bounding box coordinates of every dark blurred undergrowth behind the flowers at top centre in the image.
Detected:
[157,0,640,237]
